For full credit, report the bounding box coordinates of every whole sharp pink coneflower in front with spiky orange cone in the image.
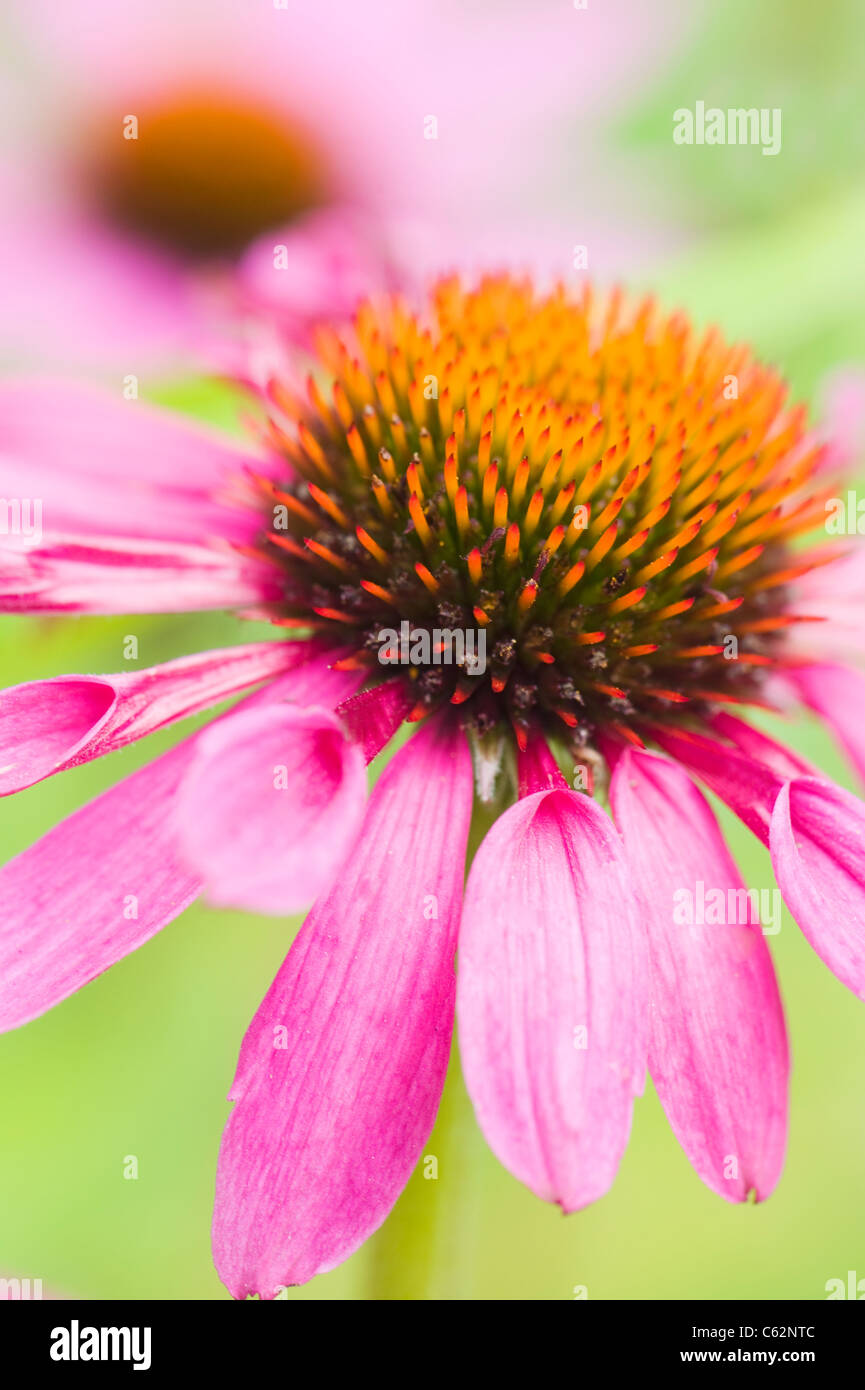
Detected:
[0,277,865,1297]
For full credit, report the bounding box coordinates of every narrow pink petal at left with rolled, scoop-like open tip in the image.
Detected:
[0,642,309,795]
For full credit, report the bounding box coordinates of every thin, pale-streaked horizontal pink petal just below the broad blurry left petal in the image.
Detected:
[0,538,281,613]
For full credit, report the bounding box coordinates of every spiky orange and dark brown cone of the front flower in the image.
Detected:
[248,277,820,741]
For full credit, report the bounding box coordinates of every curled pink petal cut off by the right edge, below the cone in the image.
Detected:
[769,777,865,999]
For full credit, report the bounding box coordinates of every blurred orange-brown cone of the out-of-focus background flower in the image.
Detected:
[92,95,327,257]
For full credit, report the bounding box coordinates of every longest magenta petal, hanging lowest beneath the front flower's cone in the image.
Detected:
[213,726,471,1298]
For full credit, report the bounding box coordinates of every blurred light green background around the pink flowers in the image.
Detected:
[0,0,865,1300]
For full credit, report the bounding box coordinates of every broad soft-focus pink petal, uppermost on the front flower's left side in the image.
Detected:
[0,378,268,542]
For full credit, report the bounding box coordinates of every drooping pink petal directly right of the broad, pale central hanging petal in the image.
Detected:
[611,749,789,1202]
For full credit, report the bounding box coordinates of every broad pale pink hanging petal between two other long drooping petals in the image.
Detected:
[458,791,647,1211]
